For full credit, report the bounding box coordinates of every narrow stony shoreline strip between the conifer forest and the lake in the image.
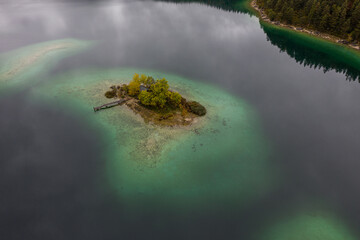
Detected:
[249,0,360,51]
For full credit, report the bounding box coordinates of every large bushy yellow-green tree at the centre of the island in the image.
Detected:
[139,77,182,108]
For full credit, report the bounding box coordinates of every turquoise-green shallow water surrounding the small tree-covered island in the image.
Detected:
[34,69,278,210]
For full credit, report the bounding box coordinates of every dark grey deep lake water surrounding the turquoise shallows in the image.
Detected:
[0,1,360,239]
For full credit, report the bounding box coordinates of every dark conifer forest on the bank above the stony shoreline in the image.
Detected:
[257,0,360,42]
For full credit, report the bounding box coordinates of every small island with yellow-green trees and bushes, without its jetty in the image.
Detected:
[102,74,206,126]
